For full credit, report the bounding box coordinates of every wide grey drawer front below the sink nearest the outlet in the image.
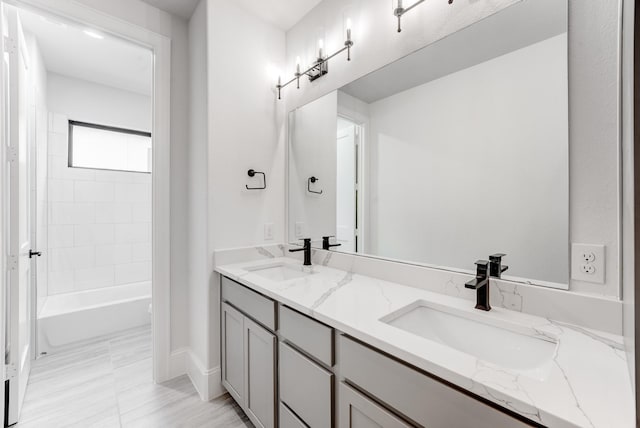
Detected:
[338,336,536,428]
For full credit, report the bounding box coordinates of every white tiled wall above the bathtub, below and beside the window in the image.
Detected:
[48,113,151,295]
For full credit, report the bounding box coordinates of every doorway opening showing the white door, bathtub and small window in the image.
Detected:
[3,4,155,425]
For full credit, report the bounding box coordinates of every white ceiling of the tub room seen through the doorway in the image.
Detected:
[20,10,153,95]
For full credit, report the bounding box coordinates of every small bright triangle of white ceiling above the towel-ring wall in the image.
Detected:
[235,0,322,31]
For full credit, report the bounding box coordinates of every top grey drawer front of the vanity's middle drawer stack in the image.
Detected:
[279,305,333,367]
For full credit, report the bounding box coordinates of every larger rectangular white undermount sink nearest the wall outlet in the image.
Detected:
[381,301,557,375]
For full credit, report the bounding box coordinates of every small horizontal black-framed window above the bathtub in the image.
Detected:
[69,120,151,173]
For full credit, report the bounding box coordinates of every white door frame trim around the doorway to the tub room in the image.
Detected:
[0,0,171,390]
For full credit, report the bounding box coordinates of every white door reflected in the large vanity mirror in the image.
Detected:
[336,124,358,252]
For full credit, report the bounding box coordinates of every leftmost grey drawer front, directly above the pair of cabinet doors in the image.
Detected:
[221,276,276,331]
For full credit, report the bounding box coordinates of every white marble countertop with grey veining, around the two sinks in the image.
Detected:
[216,258,635,428]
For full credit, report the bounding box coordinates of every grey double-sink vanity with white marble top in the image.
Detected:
[216,251,632,428]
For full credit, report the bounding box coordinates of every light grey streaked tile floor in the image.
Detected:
[15,327,252,428]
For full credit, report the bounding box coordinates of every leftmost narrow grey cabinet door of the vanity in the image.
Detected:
[221,303,245,404]
